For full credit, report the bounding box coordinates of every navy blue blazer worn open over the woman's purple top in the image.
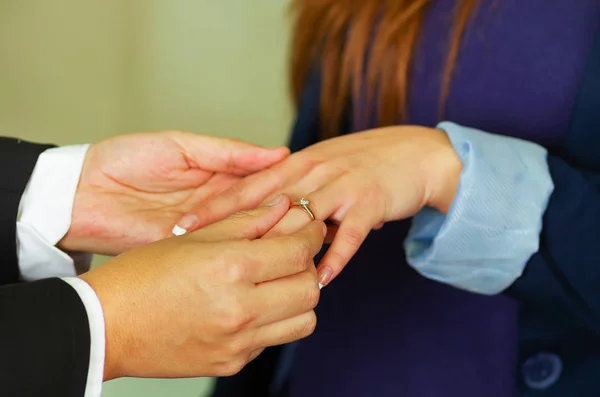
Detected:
[214,25,600,397]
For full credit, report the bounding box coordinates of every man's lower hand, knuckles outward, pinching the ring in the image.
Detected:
[81,196,325,380]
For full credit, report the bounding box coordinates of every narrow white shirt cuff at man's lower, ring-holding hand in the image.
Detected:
[63,277,106,397]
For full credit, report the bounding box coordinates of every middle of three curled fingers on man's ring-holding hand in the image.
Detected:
[250,265,320,326]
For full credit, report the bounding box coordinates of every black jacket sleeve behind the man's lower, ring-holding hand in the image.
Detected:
[0,278,90,397]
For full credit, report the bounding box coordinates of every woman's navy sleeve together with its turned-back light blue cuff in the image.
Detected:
[398,123,600,332]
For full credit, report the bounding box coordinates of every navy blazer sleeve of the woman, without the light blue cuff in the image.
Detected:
[505,156,600,332]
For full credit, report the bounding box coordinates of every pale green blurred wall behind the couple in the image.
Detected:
[0,0,292,397]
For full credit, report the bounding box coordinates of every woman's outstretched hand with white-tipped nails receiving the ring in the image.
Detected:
[173,126,462,285]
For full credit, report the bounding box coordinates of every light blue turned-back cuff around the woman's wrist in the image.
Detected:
[404,122,554,295]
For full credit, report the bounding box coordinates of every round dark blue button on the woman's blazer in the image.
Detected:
[521,352,563,390]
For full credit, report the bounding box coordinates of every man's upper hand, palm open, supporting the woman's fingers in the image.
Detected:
[59,131,289,255]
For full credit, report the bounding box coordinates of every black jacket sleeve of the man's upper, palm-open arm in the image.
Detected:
[0,137,52,285]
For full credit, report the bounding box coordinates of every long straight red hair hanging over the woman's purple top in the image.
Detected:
[291,0,478,139]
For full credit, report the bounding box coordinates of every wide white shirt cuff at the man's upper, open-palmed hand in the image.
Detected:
[17,145,91,281]
